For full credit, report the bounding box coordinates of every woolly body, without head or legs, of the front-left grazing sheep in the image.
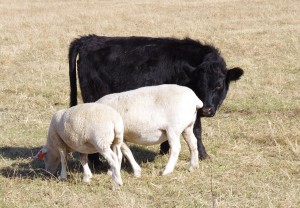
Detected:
[50,103,123,153]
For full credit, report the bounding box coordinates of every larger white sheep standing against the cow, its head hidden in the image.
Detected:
[97,85,203,177]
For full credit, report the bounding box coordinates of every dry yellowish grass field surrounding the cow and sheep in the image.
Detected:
[0,0,300,208]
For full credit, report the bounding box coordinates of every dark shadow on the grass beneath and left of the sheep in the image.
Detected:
[0,146,158,180]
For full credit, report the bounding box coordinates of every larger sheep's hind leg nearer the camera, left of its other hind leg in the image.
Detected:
[162,130,181,175]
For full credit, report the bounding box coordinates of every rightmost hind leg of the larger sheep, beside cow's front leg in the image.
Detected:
[182,125,199,171]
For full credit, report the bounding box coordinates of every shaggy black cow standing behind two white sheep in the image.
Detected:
[69,35,244,164]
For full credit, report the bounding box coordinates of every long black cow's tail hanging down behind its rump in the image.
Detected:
[69,39,81,107]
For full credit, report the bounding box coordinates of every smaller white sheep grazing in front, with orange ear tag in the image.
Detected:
[35,103,124,185]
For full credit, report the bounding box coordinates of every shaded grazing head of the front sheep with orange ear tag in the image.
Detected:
[34,147,60,174]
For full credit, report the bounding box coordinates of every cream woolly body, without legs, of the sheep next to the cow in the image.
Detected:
[97,85,203,145]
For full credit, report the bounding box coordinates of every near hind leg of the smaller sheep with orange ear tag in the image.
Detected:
[98,148,123,185]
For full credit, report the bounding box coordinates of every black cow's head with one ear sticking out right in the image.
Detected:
[189,53,244,117]
